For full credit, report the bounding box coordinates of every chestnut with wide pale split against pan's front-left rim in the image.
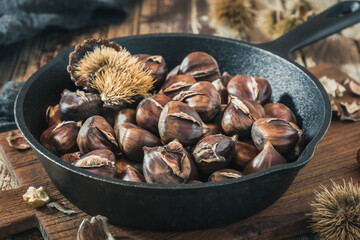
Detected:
[73,149,116,177]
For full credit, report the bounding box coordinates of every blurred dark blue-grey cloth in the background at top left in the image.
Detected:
[0,0,131,46]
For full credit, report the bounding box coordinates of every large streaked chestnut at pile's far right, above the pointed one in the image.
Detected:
[251,118,301,155]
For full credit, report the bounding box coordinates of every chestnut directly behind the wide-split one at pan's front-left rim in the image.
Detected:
[77,115,118,154]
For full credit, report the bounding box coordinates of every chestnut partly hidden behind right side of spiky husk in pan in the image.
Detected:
[133,54,168,88]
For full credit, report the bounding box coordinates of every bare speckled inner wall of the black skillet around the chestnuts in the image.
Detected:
[23,34,326,165]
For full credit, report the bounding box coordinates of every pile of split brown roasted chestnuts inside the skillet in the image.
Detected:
[40,52,304,184]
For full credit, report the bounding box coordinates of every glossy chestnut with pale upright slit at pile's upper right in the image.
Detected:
[227,75,271,104]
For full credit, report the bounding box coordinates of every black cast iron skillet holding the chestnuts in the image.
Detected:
[15,2,360,230]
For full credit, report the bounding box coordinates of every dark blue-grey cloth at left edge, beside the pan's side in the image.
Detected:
[0,81,24,132]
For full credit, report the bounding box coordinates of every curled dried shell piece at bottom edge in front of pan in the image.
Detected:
[77,215,115,240]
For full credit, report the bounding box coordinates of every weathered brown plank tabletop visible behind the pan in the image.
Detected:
[0,0,360,239]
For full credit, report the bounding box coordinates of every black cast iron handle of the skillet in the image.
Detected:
[257,1,360,58]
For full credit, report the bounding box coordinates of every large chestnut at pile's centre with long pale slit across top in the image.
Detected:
[159,101,209,146]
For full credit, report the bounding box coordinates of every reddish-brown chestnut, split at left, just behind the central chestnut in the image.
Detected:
[173,81,221,122]
